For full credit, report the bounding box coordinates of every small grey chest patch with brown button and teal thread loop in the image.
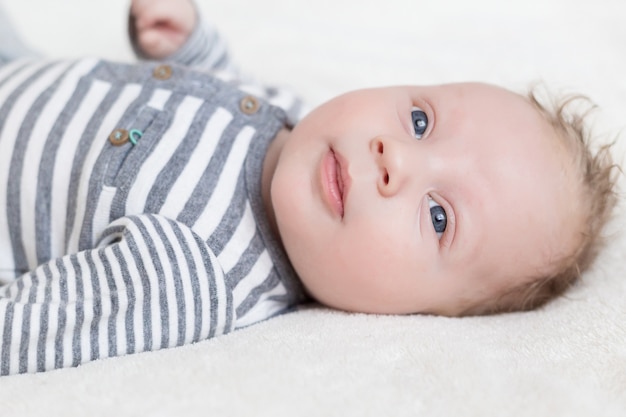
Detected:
[104,106,171,187]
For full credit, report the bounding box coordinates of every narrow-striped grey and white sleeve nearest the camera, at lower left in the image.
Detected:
[0,215,234,375]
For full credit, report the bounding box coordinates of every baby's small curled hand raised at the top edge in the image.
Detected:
[130,0,197,59]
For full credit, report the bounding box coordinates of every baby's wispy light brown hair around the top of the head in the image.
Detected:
[461,87,620,315]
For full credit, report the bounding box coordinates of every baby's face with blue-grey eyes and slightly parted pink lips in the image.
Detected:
[271,84,571,314]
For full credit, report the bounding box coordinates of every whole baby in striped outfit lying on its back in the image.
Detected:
[0,0,615,375]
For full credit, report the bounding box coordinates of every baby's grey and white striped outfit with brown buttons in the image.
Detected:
[0,17,305,375]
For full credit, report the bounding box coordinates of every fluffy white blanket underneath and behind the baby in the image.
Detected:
[0,0,626,417]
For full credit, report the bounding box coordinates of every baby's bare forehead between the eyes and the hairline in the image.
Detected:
[421,84,572,287]
